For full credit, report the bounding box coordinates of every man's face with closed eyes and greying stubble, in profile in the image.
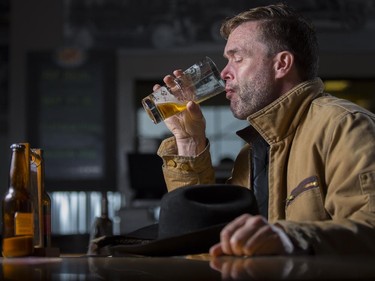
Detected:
[221,22,279,120]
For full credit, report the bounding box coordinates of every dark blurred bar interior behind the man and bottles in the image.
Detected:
[0,0,375,251]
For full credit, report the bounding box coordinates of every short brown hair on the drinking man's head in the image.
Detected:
[220,4,319,80]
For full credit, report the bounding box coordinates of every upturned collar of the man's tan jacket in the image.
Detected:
[237,78,324,144]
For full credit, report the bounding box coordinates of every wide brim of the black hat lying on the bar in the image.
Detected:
[92,223,226,256]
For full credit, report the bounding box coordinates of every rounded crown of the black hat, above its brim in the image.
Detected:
[158,184,258,239]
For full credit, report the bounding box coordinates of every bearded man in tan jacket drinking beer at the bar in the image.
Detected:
[154,4,375,256]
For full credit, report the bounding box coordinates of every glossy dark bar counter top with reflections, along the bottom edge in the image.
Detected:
[0,255,375,281]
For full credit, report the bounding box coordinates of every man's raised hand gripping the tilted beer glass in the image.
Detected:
[153,70,206,156]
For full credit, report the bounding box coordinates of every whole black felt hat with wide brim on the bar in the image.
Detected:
[89,184,258,256]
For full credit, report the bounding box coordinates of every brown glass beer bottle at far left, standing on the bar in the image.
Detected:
[2,144,34,257]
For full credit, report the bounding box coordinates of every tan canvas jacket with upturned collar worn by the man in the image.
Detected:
[158,78,375,254]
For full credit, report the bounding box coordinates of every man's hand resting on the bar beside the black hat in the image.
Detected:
[210,214,295,256]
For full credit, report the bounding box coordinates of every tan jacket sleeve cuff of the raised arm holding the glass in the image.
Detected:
[157,137,215,191]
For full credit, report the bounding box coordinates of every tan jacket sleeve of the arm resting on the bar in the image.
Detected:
[276,110,375,255]
